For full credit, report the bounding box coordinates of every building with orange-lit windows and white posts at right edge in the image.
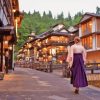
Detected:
[79,13,100,62]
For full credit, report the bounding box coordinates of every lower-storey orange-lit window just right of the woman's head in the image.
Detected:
[82,36,93,49]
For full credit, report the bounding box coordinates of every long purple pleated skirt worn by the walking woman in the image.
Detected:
[71,53,88,87]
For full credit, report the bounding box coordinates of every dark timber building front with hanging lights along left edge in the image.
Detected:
[0,0,22,73]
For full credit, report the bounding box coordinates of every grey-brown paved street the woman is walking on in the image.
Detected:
[0,68,100,100]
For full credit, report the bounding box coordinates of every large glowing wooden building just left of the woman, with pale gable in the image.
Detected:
[28,24,71,63]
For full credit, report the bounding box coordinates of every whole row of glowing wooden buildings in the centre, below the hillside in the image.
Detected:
[18,24,72,67]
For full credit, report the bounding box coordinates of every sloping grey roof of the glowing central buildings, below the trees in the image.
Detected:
[23,24,69,45]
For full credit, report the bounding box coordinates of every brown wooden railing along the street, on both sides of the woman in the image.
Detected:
[17,62,100,77]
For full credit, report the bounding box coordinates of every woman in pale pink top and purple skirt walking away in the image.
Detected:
[70,36,88,94]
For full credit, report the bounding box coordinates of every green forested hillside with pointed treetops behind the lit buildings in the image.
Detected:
[16,10,82,51]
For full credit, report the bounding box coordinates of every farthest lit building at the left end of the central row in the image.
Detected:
[16,32,38,67]
